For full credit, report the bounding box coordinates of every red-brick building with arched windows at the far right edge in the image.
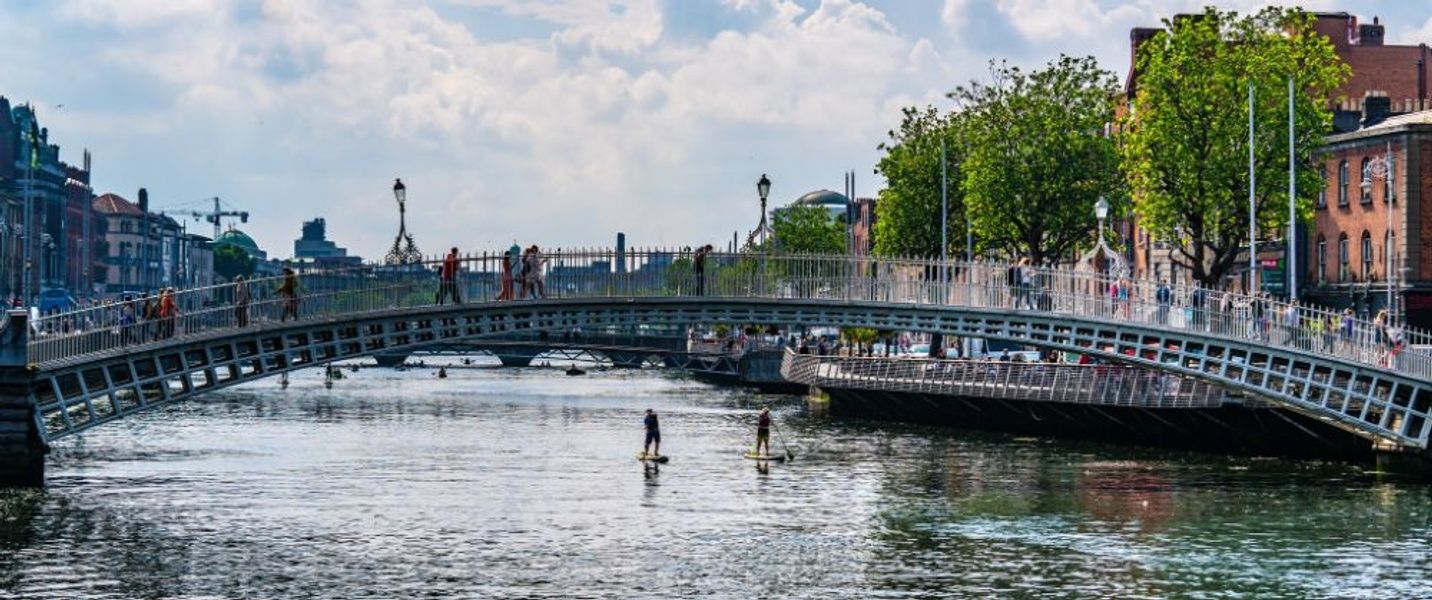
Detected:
[1299,110,1432,328]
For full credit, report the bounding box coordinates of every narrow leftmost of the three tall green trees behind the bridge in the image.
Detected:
[872,106,965,258]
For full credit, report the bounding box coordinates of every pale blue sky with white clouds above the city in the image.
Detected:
[0,0,1432,258]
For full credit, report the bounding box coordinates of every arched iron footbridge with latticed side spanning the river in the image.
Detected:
[0,251,1432,484]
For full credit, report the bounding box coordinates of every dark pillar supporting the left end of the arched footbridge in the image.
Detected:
[0,309,49,488]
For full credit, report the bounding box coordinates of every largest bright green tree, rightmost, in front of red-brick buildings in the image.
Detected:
[1120,7,1350,286]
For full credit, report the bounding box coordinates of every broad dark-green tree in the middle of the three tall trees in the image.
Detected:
[949,56,1123,263]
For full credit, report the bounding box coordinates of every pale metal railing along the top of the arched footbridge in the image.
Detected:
[29,249,1432,377]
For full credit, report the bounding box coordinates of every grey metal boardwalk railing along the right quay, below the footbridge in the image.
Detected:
[780,349,1237,408]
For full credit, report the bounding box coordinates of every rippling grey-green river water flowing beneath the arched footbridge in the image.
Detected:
[0,363,1432,599]
